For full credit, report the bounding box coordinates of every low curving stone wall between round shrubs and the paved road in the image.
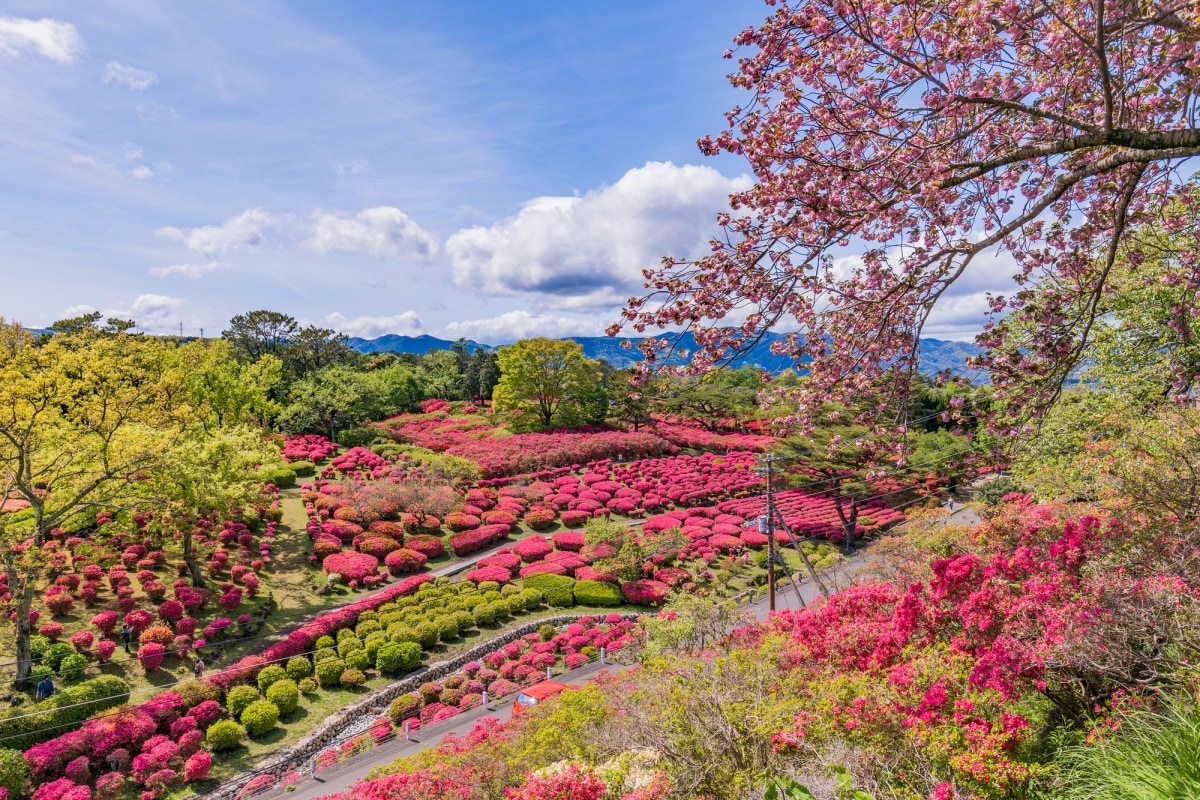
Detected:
[202,613,640,800]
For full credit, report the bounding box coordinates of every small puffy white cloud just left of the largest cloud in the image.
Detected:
[307,205,438,263]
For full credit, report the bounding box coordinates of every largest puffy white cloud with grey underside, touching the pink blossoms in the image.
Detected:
[446,162,750,308]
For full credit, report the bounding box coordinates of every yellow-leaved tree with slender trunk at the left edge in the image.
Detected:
[0,330,179,682]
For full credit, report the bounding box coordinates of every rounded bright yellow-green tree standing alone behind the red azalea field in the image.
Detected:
[492,338,600,429]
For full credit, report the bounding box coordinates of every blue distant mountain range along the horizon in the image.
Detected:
[348,333,980,380]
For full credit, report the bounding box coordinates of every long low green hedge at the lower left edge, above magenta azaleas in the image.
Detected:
[0,675,130,750]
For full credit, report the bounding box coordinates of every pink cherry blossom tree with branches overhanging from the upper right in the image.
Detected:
[611,0,1200,432]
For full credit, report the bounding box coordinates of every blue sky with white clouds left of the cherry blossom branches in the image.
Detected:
[0,0,993,343]
